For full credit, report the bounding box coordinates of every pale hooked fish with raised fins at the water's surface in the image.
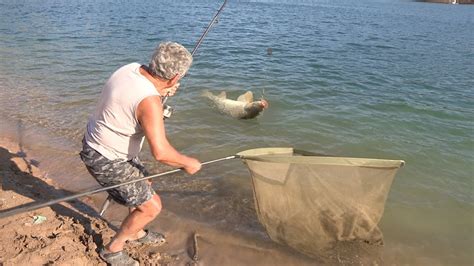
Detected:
[202,90,268,119]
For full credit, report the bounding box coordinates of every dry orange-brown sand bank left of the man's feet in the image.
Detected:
[0,138,108,265]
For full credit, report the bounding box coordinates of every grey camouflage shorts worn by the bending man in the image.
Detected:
[80,142,155,207]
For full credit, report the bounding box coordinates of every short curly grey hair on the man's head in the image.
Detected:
[148,42,193,79]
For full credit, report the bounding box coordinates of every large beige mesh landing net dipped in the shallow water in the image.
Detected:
[239,148,403,256]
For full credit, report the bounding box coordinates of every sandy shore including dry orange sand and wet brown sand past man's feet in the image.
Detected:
[0,137,318,265]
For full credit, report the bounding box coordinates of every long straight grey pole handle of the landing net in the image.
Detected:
[0,155,239,219]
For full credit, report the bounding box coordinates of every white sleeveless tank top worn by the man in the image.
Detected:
[85,63,160,160]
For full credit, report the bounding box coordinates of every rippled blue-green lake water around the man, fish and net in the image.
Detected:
[0,0,474,265]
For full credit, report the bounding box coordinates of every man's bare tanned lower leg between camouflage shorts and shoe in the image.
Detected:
[106,194,161,252]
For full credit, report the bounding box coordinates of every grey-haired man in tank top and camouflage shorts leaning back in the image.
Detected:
[80,42,201,265]
